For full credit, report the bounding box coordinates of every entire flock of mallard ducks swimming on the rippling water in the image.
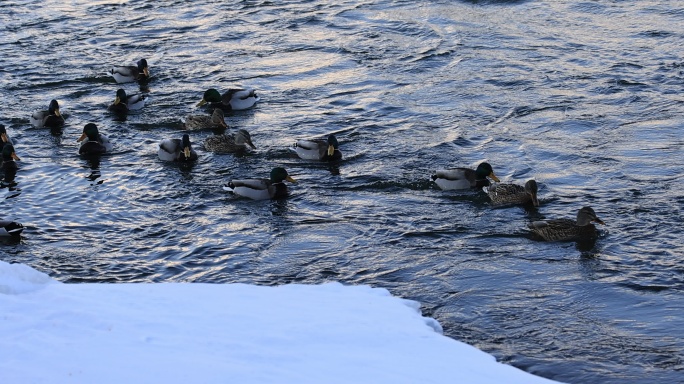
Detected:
[0,59,604,241]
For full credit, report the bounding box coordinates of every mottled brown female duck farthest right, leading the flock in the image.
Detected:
[528,207,605,241]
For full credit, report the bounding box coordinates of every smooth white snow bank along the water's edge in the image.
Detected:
[0,261,554,384]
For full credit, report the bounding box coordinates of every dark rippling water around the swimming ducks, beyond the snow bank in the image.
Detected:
[0,0,684,383]
